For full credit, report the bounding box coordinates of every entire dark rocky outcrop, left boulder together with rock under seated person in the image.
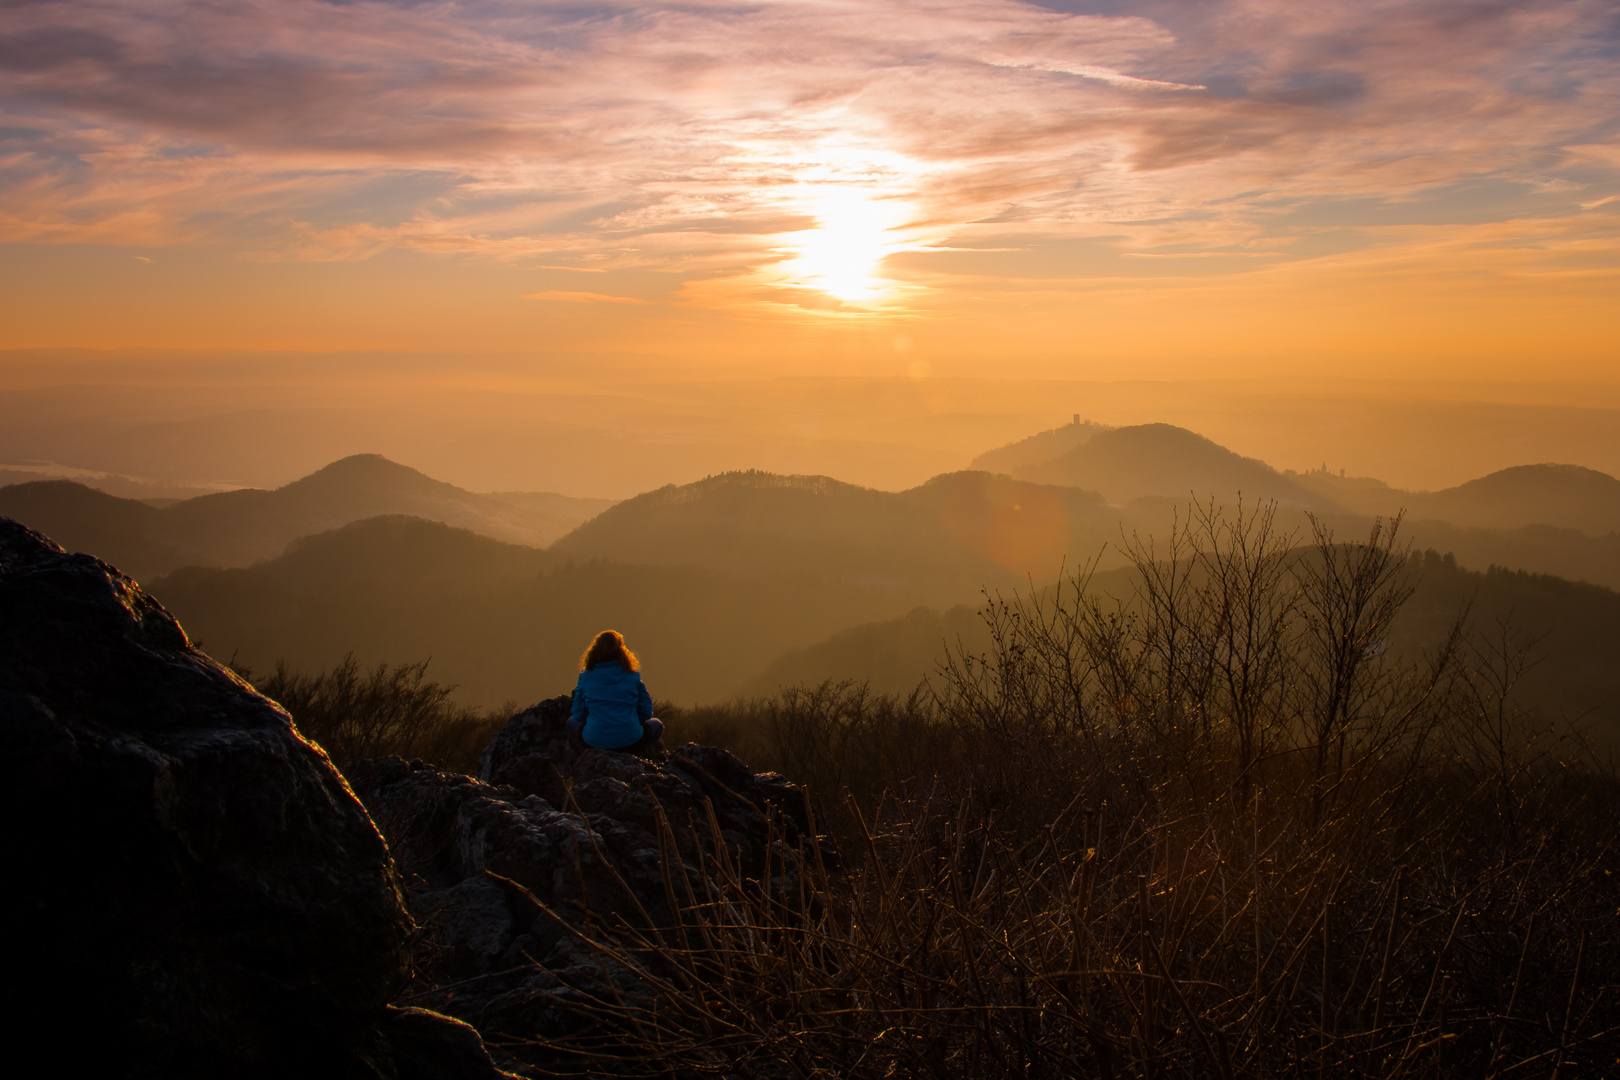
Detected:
[0,518,808,1080]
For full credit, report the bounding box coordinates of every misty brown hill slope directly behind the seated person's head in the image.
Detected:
[147,517,926,706]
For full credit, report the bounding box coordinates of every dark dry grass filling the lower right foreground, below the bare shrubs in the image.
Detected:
[518,735,1620,1078]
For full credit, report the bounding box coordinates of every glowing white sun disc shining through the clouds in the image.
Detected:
[784,188,906,303]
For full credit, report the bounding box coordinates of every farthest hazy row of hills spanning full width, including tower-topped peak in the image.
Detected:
[0,424,1620,607]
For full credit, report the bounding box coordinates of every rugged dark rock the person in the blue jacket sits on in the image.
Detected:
[350,696,808,1056]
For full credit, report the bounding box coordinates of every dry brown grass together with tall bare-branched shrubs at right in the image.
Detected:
[525,513,1620,1080]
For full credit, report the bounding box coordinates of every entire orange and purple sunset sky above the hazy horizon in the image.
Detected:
[0,0,1620,381]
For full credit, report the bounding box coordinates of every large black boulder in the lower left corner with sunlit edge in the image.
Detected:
[0,518,499,1080]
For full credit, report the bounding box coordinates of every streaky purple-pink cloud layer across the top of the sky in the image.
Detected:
[0,0,1620,298]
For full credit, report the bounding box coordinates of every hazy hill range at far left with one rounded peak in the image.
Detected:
[0,453,612,578]
